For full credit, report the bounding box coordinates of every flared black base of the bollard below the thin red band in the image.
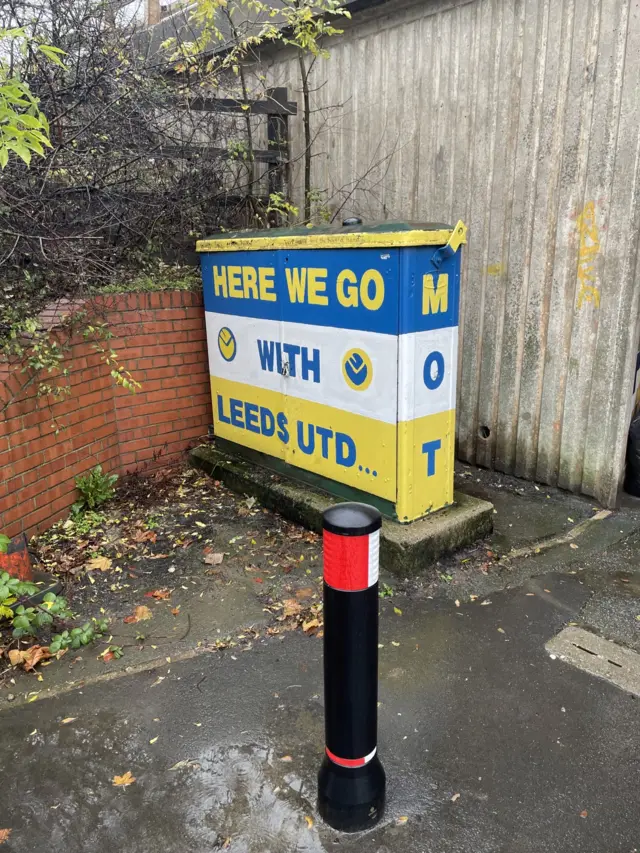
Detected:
[318,755,386,832]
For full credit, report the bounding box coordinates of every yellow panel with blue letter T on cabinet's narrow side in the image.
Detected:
[397,409,455,521]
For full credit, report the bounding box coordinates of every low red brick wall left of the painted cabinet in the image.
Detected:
[0,291,212,536]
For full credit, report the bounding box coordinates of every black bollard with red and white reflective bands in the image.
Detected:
[318,503,385,832]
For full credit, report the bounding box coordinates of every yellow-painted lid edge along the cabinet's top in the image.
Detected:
[196,226,456,252]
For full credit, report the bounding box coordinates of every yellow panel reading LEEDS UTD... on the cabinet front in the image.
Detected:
[211,376,397,503]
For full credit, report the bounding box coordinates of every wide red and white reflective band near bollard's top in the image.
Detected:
[323,530,380,592]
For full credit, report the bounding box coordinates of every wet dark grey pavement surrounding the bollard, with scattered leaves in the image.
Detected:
[0,574,640,853]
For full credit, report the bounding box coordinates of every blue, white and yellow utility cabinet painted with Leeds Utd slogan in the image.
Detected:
[197,222,466,522]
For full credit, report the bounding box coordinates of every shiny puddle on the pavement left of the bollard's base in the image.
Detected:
[12,715,325,853]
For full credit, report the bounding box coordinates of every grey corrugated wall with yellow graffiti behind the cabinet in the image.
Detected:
[272,0,640,504]
